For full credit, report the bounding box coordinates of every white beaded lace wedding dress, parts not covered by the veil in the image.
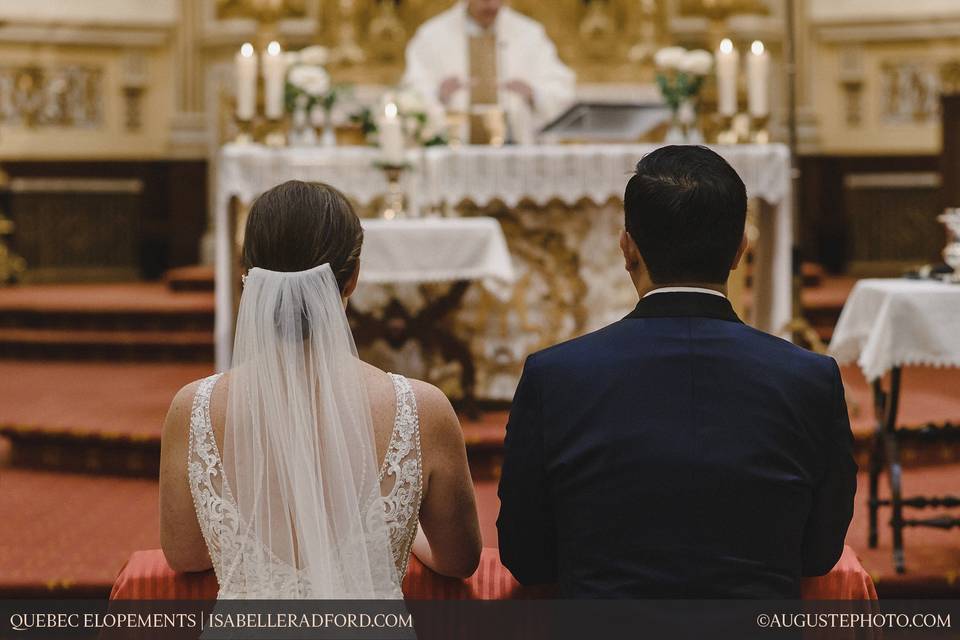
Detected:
[187,374,423,598]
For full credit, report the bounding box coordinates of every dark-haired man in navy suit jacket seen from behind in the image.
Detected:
[497,146,857,598]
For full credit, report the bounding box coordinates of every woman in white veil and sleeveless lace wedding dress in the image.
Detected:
[160,181,481,599]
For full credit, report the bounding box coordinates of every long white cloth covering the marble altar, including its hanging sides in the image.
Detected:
[214,144,793,368]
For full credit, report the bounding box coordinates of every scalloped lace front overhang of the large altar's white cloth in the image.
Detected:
[217,144,791,207]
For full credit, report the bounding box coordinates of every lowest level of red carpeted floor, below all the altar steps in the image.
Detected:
[0,465,960,598]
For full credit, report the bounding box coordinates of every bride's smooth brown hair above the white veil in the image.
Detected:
[243,180,363,292]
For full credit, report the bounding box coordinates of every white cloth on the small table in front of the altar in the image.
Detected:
[360,217,515,299]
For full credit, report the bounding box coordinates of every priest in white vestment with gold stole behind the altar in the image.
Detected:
[404,0,576,144]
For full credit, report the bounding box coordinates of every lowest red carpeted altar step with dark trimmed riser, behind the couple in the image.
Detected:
[0,360,960,480]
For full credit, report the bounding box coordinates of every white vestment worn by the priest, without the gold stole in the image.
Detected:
[403,2,576,143]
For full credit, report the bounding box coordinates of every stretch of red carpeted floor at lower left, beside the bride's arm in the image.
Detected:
[0,469,160,598]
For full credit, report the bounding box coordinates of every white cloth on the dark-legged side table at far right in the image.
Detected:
[830,278,960,380]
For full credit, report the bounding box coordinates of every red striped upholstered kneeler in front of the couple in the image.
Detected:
[110,547,877,600]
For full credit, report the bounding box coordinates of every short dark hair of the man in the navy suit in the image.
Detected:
[623,145,747,284]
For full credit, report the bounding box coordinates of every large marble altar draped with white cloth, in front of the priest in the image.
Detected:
[214,144,793,401]
